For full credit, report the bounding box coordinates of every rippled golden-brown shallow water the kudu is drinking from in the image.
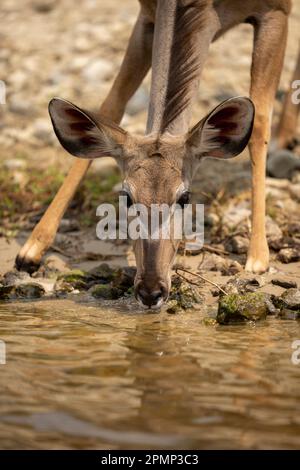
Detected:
[0,300,300,449]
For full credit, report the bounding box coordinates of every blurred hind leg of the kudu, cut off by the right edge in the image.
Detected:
[276,43,300,148]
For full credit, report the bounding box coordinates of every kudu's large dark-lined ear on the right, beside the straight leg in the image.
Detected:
[186,97,255,158]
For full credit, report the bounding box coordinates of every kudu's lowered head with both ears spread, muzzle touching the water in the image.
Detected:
[49,97,254,307]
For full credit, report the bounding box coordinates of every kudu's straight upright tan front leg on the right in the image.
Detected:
[246,10,287,273]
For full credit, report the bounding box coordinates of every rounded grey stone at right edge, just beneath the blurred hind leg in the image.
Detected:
[267,150,300,180]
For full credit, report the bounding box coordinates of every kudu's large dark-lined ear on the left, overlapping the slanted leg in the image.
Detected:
[49,98,127,159]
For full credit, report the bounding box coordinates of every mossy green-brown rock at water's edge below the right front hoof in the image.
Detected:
[217,292,268,325]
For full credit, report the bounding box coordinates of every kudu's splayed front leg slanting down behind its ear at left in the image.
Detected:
[16,14,153,273]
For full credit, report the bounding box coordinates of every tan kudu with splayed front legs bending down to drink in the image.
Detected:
[16,0,291,307]
